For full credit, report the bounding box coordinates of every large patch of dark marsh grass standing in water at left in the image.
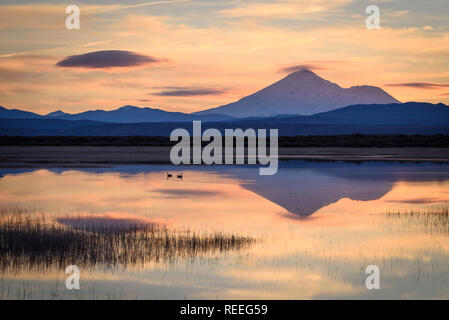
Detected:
[0,209,255,273]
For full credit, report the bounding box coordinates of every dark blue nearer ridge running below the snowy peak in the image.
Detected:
[0,102,449,136]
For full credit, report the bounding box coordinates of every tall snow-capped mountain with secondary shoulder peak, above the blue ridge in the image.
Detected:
[196,69,399,118]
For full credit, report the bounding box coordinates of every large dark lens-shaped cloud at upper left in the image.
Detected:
[56,50,163,69]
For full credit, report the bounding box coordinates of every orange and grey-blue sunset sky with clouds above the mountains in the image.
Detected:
[0,0,449,114]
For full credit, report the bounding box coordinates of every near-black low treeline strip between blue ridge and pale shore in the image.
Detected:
[0,134,449,148]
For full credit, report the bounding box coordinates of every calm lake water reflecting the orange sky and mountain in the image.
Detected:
[0,161,449,299]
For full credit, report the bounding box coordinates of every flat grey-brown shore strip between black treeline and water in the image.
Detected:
[0,146,449,168]
